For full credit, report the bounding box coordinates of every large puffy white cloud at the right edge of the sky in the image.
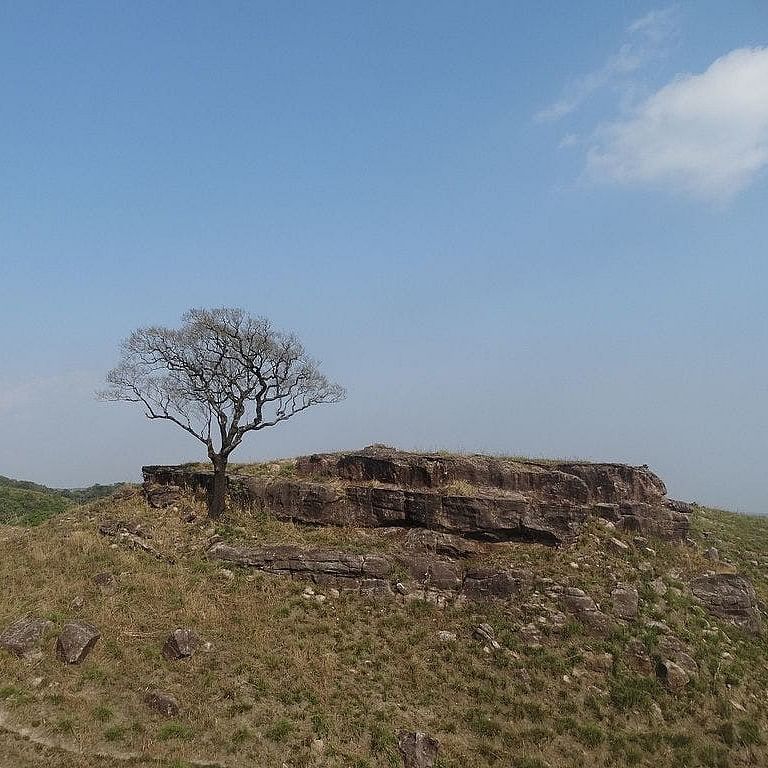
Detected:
[587,48,768,201]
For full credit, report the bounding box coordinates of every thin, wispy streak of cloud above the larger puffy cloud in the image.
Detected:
[535,6,677,122]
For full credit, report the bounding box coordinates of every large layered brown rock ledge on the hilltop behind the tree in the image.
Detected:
[143,446,688,544]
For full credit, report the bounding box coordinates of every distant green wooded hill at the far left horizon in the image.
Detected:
[0,475,122,525]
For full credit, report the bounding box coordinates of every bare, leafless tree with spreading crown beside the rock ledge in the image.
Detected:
[98,307,345,517]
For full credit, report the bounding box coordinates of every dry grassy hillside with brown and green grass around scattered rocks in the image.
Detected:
[0,490,768,768]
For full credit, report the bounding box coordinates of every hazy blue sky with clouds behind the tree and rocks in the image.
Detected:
[0,0,768,512]
